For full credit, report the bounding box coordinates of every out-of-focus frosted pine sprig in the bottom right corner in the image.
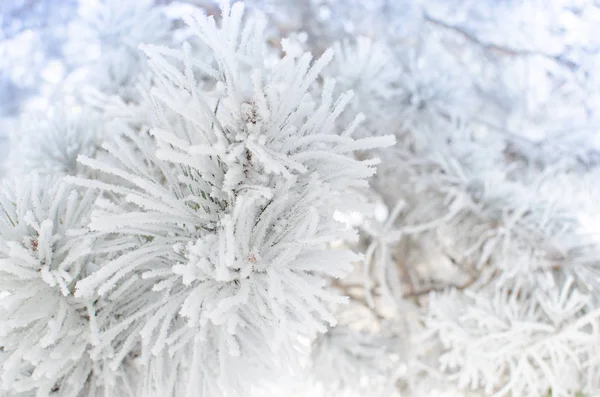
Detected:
[425,275,600,397]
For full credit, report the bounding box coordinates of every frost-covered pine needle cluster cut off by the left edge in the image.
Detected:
[0,173,141,397]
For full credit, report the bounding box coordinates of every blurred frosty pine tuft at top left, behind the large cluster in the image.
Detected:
[67,0,172,103]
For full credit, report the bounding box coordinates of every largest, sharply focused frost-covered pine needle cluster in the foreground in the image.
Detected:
[65,3,394,397]
